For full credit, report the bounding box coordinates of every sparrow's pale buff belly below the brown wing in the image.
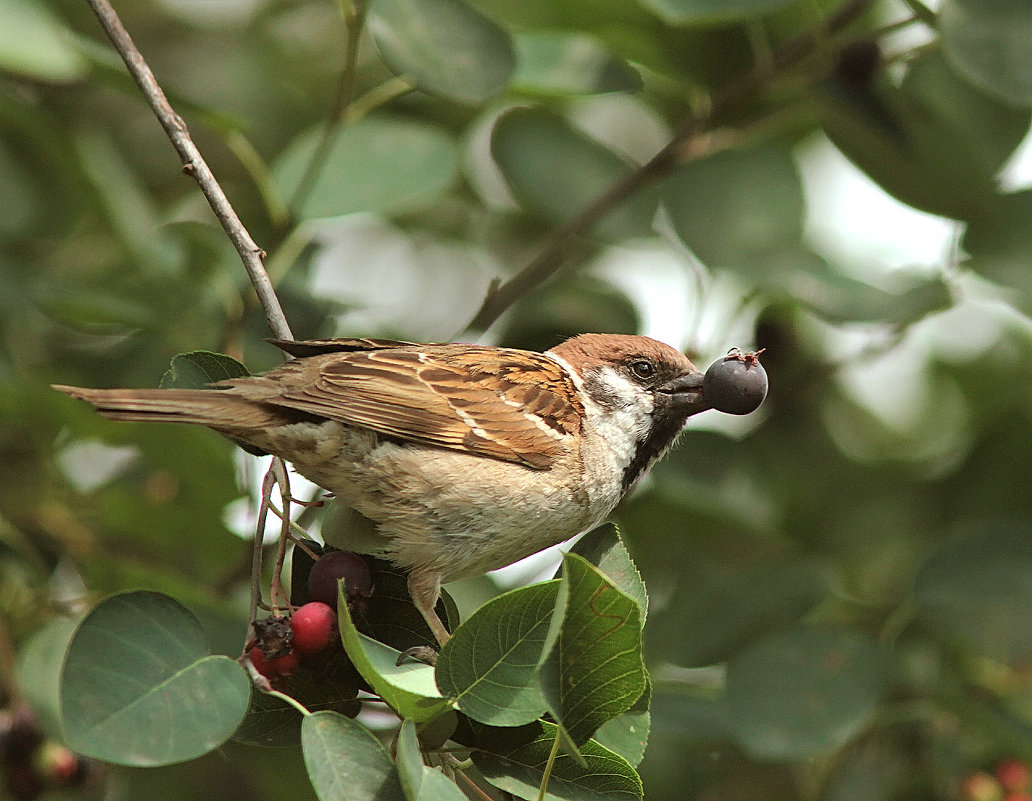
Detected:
[264,423,620,582]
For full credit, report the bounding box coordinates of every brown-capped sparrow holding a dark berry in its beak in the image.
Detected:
[55,333,730,644]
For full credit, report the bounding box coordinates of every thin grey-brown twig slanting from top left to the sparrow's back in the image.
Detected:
[87,0,294,340]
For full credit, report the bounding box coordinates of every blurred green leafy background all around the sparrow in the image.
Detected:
[0,0,1032,799]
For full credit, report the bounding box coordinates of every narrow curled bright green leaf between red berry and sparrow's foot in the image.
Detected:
[337,597,451,723]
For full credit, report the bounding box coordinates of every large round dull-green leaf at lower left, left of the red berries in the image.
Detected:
[61,592,251,766]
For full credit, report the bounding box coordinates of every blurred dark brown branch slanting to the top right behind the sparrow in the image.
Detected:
[466,0,873,331]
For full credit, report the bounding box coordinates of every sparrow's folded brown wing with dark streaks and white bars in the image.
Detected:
[226,343,583,470]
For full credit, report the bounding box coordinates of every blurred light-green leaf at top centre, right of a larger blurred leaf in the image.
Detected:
[513,31,642,95]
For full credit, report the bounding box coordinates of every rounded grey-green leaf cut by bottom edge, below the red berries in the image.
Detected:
[301,712,404,801]
